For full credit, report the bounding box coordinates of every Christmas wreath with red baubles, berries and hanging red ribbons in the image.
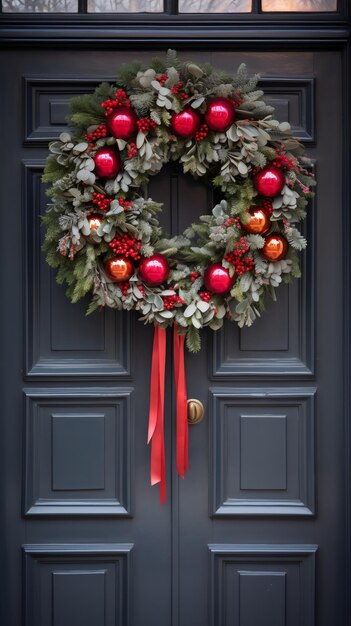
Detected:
[43,50,314,495]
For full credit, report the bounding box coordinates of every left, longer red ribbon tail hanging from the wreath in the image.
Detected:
[148,326,166,504]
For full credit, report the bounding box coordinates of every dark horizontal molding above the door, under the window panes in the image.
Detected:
[0,0,351,50]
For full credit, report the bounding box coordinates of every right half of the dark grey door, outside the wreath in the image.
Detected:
[179,51,344,626]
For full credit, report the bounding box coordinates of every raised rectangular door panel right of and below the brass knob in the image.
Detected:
[208,387,315,516]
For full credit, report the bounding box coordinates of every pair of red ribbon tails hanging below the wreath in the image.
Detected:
[147,325,188,504]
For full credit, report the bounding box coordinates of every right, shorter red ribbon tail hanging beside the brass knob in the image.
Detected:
[173,324,189,478]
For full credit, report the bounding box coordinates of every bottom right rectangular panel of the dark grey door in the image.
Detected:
[209,544,316,626]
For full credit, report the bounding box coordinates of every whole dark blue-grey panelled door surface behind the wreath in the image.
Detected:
[1,44,346,626]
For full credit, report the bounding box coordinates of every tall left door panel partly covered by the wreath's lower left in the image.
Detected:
[23,159,131,378]
